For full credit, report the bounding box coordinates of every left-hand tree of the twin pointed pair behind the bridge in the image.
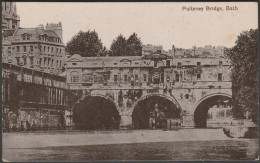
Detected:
[109,34,127,56]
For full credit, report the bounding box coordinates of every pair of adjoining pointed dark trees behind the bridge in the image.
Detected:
[109,33,142,56]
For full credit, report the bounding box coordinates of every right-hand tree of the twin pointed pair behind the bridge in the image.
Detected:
[126,33,142,56]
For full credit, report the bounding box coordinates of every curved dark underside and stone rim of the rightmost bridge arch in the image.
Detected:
[193,93,232,128]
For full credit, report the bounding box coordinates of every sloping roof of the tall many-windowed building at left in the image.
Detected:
[14,28,59,37]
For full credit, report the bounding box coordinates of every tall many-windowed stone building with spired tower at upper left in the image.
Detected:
[2,2,66,74]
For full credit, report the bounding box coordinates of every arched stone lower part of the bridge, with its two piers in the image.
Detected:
[67,84,232,127]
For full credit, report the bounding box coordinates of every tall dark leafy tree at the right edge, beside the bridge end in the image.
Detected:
[226,29,259,123]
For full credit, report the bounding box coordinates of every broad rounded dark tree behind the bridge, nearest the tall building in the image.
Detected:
[66,31,103,57]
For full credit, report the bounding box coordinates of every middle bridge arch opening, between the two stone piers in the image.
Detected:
[132,94,181,129]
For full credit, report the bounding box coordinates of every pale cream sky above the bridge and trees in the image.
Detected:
[16,2,258,50]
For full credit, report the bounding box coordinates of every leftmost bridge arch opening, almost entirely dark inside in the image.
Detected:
[73,95,120,130]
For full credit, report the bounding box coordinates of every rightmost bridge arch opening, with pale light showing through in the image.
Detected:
[194,93,232,128]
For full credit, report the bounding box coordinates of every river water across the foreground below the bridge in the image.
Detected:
[3,130,259,161]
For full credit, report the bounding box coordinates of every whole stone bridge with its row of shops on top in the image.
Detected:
[66,47,232,128]
